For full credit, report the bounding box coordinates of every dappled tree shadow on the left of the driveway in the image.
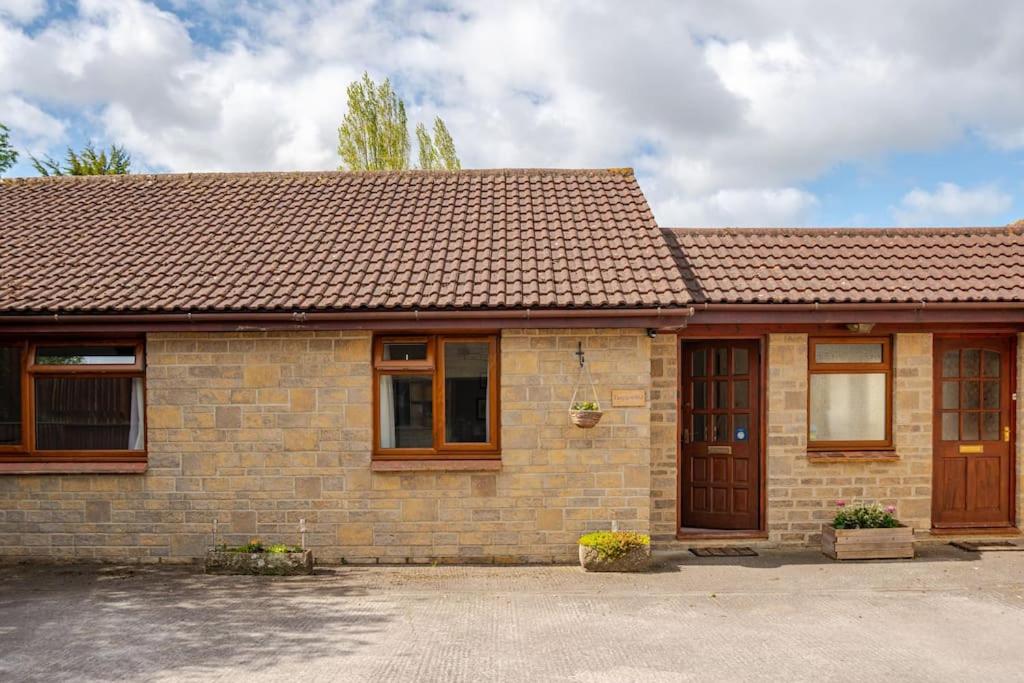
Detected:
[0,565,393,680]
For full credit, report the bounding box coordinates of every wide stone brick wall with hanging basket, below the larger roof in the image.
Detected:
[0,330,651,562]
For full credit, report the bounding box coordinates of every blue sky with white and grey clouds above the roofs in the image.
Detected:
[0,0,1024,226]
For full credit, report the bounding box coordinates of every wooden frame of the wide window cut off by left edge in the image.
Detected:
[0,338,148,464]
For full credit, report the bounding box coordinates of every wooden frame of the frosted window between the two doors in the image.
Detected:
[807,336,894,452]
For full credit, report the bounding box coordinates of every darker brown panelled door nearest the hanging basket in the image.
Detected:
[679,340,761,529]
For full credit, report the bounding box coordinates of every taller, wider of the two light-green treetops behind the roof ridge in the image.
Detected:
[338,73,409,171]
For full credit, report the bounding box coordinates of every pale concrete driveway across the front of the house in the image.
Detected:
[0,546,1024,683]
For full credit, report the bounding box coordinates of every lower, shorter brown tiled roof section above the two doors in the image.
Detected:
[664,227,1024,303]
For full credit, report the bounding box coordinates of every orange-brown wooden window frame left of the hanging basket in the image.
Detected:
[373,332,501,461]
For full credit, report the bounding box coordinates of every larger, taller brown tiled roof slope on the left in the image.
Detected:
[0,169,686,312]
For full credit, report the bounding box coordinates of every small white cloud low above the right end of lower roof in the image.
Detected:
[893,182,1013,225]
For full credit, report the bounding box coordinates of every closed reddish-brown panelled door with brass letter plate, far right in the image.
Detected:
[932,337,1013,527]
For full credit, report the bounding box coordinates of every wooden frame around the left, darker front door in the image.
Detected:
[676,330,768,541]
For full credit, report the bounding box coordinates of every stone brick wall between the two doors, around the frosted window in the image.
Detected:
[767,334,932,543]
